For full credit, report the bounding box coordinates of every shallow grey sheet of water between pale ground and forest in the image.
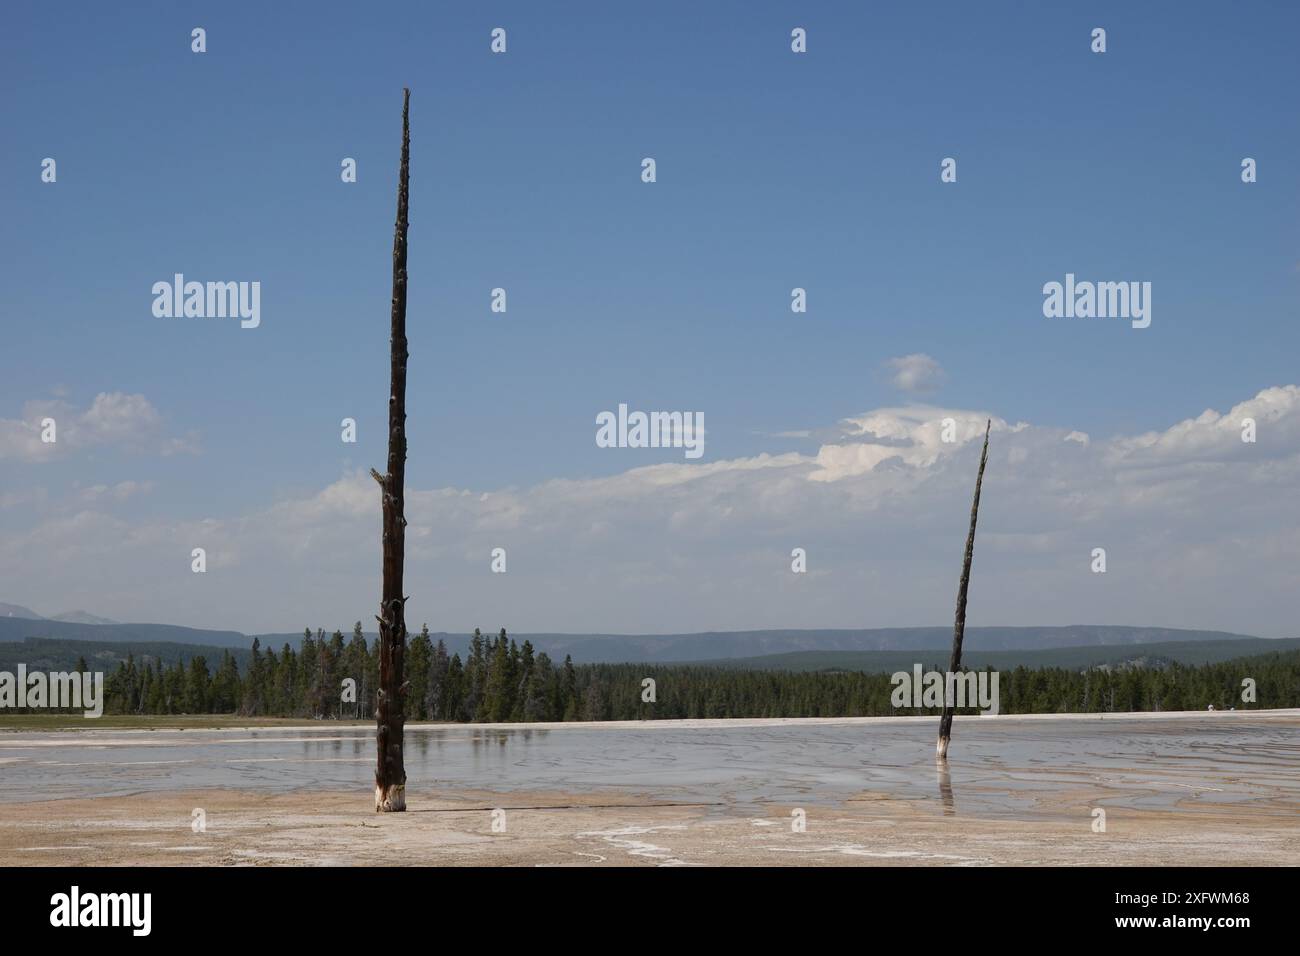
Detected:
[0,717,1300,816]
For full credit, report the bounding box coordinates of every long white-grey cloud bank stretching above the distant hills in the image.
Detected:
[0,385,1300,636]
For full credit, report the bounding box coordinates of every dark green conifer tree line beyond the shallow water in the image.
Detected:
[91,623,1300,722]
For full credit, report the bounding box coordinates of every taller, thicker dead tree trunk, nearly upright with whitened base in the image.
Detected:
[371,90,411,812]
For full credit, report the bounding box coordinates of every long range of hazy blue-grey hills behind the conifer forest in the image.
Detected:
[0,604,1281,666]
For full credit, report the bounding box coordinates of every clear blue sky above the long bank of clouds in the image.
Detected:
[0,3,1300,631]
